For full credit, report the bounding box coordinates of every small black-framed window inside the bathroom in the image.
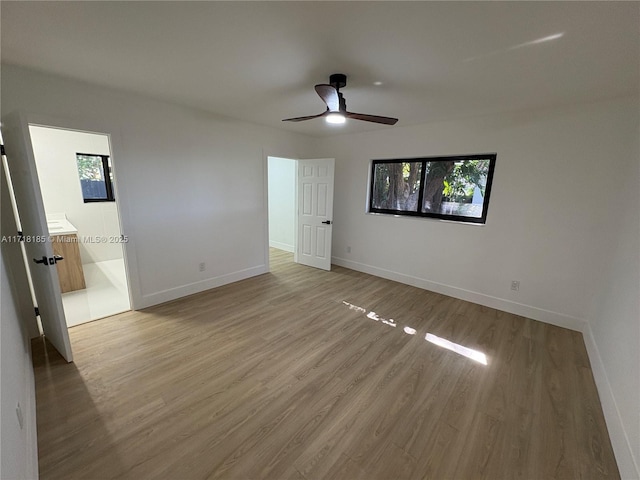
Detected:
[76,153,115,203]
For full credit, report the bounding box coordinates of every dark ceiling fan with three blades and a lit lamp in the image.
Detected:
[282,73,398,125]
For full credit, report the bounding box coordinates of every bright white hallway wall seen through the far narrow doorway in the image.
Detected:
[269,157,296,252]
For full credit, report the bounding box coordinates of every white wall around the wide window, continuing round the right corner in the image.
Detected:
[321,98,640,478]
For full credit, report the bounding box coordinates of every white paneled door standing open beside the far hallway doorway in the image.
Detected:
[295,158,335,270]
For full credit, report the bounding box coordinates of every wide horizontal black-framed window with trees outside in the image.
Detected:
[369,153,496,223]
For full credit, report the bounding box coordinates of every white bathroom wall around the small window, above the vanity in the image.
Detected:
[29,126,123,264]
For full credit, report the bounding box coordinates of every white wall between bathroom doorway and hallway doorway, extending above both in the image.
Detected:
[1,65,314,308]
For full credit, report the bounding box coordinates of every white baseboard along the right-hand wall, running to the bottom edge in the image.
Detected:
[582,324,640,480]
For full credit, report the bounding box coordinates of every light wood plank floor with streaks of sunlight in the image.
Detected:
[33,250,619,480]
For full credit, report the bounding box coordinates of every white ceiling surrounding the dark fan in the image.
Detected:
[0,0,640,136]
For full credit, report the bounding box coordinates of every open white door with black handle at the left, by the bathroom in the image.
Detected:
[2,113,73,362]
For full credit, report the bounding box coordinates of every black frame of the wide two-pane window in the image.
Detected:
[368,153,497,224]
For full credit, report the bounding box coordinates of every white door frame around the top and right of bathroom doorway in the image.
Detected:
[25,113,143,310]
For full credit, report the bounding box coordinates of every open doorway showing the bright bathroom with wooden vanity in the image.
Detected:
[29,125,131,327]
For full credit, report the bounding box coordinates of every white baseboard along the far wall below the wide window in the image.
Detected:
[331,257,587,332]
